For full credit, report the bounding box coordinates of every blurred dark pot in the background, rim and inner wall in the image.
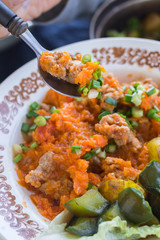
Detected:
[89,0,160,39]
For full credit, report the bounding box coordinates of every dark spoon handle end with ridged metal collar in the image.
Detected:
[0,0,28,37]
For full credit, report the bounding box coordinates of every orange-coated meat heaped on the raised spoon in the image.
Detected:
[40,52,83,84]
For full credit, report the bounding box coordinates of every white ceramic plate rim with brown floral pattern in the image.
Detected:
[0,38,160,240]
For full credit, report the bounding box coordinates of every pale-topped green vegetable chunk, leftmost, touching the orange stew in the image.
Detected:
[64,188,109,217]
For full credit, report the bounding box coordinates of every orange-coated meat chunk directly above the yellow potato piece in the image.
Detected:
[102,157,140,181]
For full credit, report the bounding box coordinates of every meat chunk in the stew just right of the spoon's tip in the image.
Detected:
[101,74,124,111]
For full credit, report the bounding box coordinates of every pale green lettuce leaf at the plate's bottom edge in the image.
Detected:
[37,210,160,240]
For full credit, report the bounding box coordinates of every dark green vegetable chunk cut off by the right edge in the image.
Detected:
[138,161,160,195]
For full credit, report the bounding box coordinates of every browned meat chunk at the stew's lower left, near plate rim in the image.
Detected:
[25,152,56,188]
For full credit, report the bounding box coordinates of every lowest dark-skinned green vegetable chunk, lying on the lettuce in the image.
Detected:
[65,217,98,236]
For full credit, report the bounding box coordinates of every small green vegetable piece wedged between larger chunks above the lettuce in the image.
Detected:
[98,201,125,224]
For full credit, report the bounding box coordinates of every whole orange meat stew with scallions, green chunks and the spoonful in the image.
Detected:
[13,53,160,236]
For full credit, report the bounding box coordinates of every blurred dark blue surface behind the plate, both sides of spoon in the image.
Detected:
[0,18,90,82]
